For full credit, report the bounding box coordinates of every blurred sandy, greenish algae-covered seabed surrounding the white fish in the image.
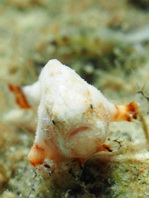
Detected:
[0,0,149,198]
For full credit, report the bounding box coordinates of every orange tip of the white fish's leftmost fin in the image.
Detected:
[8,84,31,109]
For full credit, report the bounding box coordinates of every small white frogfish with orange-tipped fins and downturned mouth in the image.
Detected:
[7,60,139,166]
